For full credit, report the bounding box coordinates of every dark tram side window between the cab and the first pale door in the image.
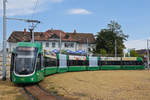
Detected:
[44,57,57,67]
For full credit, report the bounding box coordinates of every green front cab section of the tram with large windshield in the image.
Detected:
[10,42,44,83]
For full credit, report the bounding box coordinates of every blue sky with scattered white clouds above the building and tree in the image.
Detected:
[0,0,150,49]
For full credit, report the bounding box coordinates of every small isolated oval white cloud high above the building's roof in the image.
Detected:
[68,8,91,15]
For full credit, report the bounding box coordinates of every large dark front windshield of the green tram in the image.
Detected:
[15,47,38,75]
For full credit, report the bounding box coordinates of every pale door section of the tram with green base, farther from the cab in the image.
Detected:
[88,56,99,70]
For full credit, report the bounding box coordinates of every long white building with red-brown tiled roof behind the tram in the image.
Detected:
[8,29,95,52]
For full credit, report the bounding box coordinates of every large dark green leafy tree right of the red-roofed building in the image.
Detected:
[95,21,128,54]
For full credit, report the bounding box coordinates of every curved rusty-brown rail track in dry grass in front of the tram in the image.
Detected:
[23,84,66,100]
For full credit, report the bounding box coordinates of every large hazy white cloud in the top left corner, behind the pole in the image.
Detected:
[0,0,48,16]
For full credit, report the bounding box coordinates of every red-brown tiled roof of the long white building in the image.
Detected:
[8,30,95,43]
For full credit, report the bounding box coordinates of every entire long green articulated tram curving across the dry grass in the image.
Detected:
[10,42,145,84]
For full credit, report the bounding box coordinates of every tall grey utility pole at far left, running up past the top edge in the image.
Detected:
[2,0,7,81]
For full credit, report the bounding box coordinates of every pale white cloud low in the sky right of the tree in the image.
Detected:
[125,39,147,50]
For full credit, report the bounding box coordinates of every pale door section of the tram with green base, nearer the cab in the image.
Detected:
[57,54,68,73]
